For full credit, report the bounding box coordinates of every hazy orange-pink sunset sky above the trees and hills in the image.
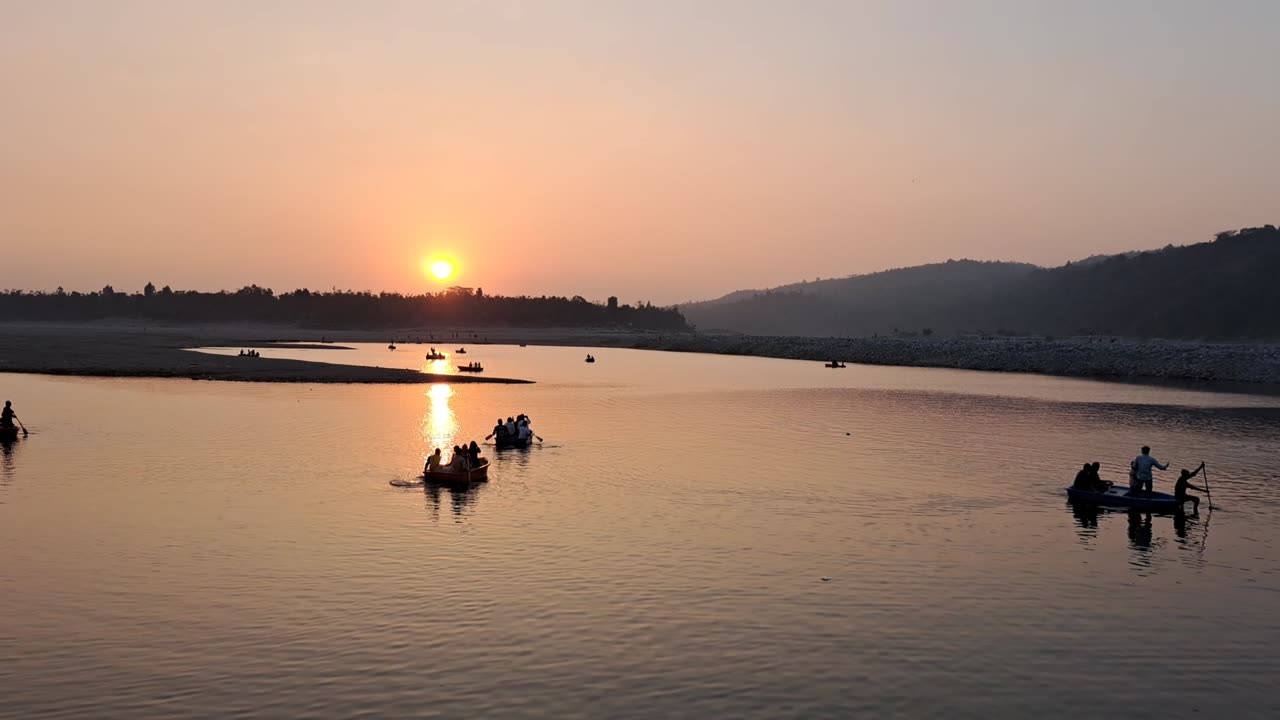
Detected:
[0,0,1280,304]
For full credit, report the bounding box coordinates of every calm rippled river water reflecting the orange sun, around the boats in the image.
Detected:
[0,346,1280,717]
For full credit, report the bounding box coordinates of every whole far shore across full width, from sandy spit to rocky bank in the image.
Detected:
[0,322,1280,391]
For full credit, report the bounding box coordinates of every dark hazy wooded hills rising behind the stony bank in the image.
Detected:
[681,225,1280,340]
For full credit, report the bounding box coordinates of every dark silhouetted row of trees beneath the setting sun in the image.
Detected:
[0,283,690,332]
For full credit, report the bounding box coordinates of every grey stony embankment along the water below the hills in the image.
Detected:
[631,334,1280,384]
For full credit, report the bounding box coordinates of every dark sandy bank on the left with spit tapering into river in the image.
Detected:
[0,323,530,383]
